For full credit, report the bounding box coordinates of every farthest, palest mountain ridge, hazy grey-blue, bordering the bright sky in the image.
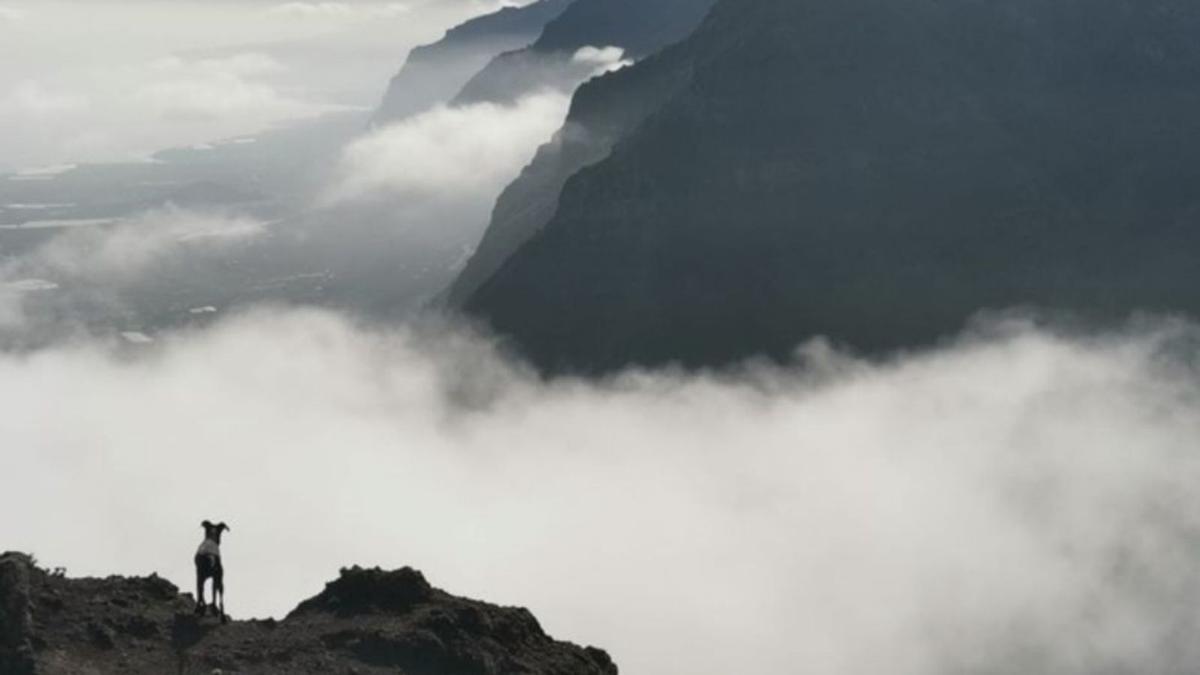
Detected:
[374,0,574,124]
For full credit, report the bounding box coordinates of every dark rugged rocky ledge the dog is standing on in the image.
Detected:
[0,554,617,675]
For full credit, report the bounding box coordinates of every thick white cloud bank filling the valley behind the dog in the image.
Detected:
[0,312,1200,675]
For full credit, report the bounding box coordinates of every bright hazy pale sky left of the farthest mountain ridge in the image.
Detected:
[0,0,530,171]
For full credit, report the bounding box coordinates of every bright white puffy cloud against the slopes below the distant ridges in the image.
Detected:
[328,92,570,202]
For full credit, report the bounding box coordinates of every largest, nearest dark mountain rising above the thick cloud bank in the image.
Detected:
[460,0,1200,371]
